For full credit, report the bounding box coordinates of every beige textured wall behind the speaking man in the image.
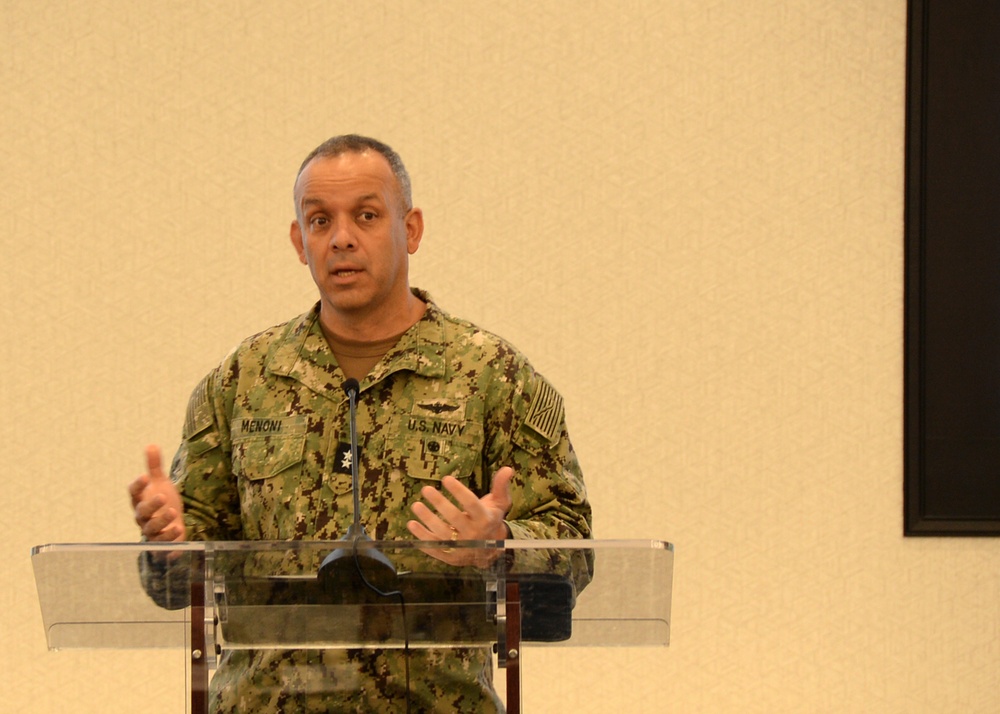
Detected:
[0,0,1000,714]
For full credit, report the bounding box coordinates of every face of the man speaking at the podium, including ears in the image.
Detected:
[291,151,423,321]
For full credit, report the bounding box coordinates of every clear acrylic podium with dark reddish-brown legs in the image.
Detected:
[31,540,673,714]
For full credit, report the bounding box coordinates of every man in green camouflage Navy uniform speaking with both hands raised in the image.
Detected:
[130,136,590,712]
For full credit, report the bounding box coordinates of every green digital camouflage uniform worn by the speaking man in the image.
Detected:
[171,290,591,714]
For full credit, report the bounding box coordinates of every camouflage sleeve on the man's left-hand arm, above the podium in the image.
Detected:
[170,366,243,540]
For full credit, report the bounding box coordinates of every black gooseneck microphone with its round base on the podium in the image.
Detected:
[318,377,396,590]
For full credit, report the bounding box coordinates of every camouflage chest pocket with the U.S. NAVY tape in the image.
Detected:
[384,416,483,483]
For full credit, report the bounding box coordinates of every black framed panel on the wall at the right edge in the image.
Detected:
[905,0,1000,535]
